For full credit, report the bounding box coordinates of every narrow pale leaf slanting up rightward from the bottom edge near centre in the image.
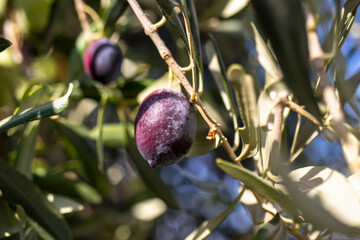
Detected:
[185,191,243,240]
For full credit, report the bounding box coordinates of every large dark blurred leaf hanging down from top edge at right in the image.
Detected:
[251,0,322,120]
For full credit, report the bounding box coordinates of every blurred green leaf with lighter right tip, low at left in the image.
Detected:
[33,173,102,204]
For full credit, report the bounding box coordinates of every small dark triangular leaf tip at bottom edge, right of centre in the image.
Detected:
[251,213,288,240]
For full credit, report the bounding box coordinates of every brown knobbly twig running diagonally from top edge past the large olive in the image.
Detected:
[127,0,242,166]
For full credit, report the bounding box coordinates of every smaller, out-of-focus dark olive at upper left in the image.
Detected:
[83,38,123,84]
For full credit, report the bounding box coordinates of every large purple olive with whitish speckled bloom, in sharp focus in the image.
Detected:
[135,88,196,167]
